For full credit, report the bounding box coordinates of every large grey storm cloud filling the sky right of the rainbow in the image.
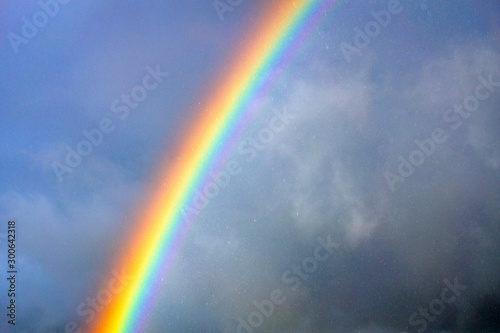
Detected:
[142,37,500,332]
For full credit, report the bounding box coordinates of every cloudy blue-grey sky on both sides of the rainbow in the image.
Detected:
[0,0,500,333]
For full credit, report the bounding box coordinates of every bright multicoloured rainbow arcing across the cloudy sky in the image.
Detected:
[89,0,339,333]
